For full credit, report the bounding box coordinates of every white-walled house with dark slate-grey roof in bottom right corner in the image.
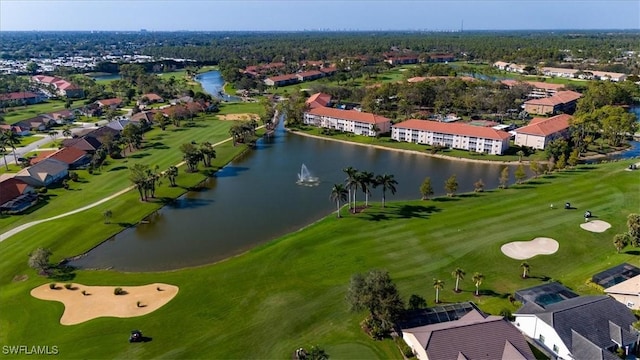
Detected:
[514,295,640,359]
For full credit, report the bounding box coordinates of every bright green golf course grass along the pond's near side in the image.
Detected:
[0,160,640,359]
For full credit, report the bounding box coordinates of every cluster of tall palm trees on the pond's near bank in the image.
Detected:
[331,166,398,217]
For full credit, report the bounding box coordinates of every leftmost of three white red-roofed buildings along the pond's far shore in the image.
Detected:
[304,107,391,136]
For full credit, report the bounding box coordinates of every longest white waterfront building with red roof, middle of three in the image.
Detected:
[391,119,511,155]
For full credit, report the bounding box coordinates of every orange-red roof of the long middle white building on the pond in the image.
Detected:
[392,119,511,140]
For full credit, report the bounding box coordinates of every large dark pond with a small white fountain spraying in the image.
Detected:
[72,118,513,271]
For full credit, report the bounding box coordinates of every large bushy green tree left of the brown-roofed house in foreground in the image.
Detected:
[347,269,404,330]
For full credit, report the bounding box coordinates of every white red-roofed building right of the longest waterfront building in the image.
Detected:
[514,114,573,149]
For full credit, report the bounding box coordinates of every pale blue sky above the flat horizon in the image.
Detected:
[0,0,640,31]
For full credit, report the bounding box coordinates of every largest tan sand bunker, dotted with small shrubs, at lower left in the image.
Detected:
[31,283,178,325]
